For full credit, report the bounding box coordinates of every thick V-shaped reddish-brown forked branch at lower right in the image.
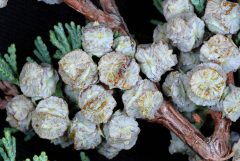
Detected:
[152,102,231,161]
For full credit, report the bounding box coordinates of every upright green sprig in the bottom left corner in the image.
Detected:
[0,129,16,161]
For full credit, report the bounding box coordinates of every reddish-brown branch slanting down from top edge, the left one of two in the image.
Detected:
[64,0,128,35]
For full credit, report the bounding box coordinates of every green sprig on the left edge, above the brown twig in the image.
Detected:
[0,44,19,85]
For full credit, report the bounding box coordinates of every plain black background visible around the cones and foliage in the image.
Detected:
[0,0,237,161]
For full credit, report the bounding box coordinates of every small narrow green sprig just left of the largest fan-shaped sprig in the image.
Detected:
[33,36,52,64]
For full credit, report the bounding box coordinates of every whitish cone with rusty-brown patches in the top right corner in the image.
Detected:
[203,0,240,34]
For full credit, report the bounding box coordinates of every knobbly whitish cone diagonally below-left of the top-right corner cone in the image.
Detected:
[167,13,205,52]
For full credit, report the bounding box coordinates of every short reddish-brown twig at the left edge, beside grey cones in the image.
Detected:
[0,81,19,109]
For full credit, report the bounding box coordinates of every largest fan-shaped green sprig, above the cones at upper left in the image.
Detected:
[50,22,81,59]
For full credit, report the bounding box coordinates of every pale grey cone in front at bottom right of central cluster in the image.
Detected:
[103,111,140,150]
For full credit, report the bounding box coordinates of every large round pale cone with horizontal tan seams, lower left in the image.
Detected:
[32,96,69,140]
